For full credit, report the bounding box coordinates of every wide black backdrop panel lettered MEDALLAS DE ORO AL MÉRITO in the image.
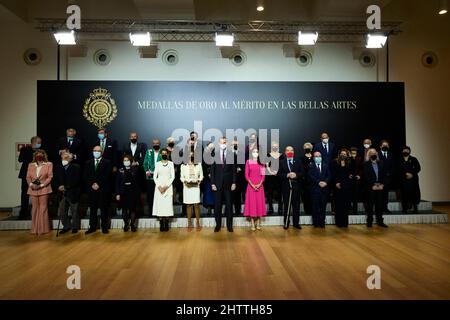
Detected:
[37,81,405,160]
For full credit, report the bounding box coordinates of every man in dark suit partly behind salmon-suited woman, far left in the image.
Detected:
[19,136,42,220]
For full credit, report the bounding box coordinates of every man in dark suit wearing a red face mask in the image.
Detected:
[277,146,302,229]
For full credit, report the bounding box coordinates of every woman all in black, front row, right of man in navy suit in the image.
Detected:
[332,149,352,228]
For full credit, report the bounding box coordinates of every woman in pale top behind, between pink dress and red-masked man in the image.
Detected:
[264,141,283,215]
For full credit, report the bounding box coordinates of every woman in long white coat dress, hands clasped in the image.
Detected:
[153,149,175,231]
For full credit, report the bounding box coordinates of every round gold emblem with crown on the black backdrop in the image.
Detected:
[83,88,117,129]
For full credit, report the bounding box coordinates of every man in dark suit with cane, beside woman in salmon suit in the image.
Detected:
[55,151,81,234]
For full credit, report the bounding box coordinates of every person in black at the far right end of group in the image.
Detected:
[399,146,421,213]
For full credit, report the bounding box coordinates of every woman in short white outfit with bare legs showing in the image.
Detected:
[180,152,203,232]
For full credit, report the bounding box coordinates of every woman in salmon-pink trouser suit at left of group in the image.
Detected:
[27,150,53,235]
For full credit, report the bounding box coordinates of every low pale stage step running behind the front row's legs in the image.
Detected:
[0,211,448,230]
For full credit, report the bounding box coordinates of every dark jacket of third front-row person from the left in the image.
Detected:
[83,158,112,192]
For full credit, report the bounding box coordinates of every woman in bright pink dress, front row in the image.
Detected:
[244,148,266,231]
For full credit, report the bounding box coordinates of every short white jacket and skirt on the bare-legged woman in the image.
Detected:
[180,164,203,204]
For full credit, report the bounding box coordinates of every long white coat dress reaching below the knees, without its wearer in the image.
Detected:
[153,161,175,217]
